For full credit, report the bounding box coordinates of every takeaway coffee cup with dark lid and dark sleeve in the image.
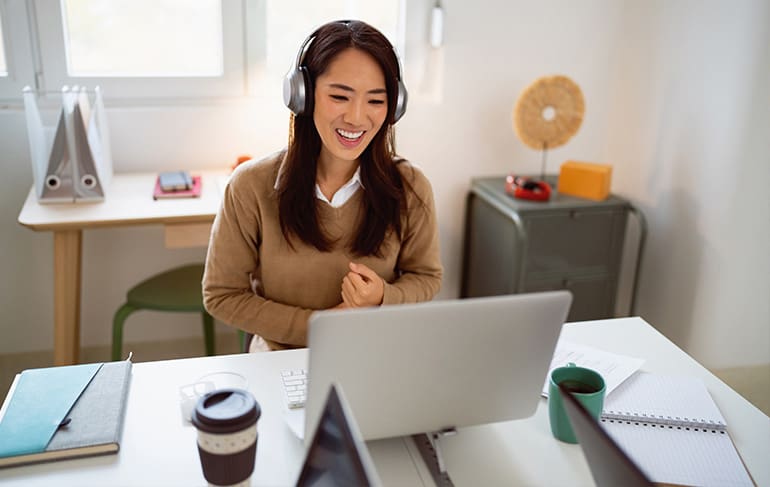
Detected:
[191,389,261,486]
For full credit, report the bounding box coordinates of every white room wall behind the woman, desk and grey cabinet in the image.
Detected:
[0,0,770,367]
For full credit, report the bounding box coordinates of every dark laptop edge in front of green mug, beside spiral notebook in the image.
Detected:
[559,385,653,487]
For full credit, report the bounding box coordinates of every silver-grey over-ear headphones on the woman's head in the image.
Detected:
[283,20,408,123]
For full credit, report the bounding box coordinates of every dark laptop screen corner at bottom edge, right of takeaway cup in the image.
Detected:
[297,384,379,487]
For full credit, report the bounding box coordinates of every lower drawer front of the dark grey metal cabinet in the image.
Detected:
[523,276,616,321]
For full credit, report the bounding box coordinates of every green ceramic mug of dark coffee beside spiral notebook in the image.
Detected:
[548,362,607,443]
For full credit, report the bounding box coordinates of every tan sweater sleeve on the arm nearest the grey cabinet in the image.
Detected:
[382,165,443,304]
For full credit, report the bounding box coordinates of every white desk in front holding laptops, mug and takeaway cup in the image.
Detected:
[0,318,770,487]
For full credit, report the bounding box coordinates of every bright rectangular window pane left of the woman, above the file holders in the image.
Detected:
[62,0,223,77]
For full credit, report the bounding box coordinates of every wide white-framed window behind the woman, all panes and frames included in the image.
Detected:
[0,0,408,103]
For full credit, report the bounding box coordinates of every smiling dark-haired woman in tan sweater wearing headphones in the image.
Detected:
[203,21,442,350]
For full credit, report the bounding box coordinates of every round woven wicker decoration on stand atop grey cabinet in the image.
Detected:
[513,75,585,178]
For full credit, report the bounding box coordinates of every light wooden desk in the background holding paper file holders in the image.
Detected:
[19,170,228,365]
